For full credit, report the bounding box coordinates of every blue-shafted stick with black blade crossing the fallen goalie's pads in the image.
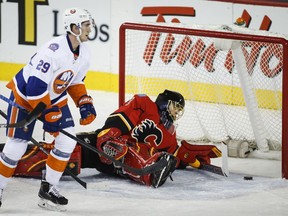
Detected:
[0,94,168,176]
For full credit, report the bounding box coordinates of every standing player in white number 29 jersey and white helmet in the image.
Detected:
[0,8,96,208]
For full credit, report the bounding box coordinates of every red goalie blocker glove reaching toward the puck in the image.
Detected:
[175,140,222,168]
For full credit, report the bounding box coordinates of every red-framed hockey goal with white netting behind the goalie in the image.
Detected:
[119,23,288,178]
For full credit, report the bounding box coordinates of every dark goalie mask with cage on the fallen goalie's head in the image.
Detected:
[155,89,185,129]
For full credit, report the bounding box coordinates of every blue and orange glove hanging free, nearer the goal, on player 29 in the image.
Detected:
[78,95,96,125]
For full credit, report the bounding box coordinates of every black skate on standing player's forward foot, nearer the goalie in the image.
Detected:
[38,180,68,211]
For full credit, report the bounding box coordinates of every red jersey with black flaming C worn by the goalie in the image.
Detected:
[102,95,178,153]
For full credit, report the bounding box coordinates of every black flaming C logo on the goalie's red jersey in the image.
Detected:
[131,119,163,146]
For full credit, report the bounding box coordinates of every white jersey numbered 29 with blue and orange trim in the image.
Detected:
[7,35,90,110]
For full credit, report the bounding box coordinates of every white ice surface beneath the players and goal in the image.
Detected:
[0,82,288,216]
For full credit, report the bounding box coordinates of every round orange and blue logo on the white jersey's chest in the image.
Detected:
[53,70,74,94]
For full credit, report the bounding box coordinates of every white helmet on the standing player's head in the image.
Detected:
[63,8,95,36]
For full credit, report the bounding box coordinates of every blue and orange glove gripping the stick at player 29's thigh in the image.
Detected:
[40,106,62,137]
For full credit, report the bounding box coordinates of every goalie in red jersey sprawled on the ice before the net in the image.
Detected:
[82,90,221,188]
